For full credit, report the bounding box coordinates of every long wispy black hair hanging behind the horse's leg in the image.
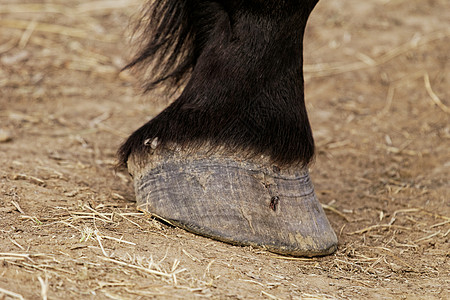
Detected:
[124,0,221,91]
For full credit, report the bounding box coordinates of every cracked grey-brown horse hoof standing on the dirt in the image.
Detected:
[128,151,337,257]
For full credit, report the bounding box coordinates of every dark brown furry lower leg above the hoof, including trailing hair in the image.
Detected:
[119,0,317,165]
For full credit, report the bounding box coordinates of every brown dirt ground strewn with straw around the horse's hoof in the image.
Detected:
[0,0,450,299]
